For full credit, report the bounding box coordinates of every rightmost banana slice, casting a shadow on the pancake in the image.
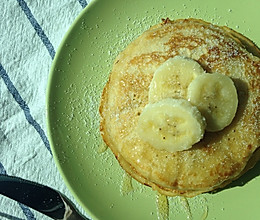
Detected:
[188,73,238,131]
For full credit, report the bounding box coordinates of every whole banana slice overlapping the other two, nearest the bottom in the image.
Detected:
[137,98,206,152]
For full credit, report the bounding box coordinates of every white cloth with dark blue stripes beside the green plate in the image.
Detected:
[0,0,90,220]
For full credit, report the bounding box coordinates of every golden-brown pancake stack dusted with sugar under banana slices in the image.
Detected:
[99,18,260,197]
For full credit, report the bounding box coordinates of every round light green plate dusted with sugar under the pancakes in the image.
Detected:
[47,0,260,220]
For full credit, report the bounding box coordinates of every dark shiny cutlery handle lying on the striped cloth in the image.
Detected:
[0,174,86,220]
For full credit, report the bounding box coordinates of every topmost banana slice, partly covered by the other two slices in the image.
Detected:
[149,56,204,103]
